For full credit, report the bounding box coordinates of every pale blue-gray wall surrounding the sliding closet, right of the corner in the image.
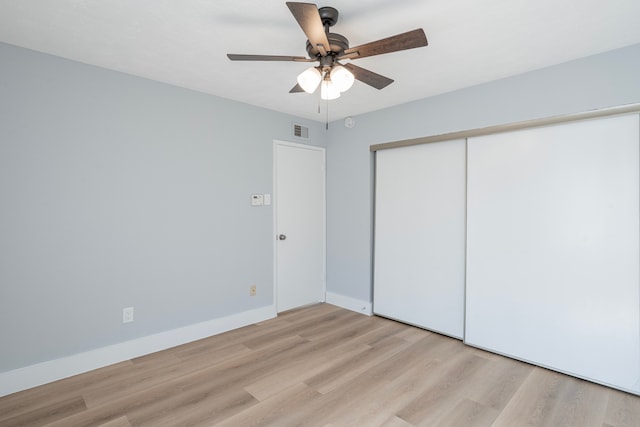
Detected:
[327,45,640,301]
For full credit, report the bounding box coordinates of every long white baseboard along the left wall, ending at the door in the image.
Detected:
[0,305,277,397]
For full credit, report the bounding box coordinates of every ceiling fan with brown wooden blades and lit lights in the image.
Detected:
[227,2,427,100]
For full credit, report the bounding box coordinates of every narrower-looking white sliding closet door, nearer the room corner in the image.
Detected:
[373,140,465,338]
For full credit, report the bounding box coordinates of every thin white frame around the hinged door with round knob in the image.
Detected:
[272,139,327,315]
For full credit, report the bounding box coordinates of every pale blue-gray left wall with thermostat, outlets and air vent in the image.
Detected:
[0,44,326,372]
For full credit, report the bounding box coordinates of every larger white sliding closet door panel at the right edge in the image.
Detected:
[465,115,640,391]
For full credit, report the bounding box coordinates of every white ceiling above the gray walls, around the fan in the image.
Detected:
[0,0,640,122]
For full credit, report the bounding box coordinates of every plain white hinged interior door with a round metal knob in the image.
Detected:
[274,142,325,312]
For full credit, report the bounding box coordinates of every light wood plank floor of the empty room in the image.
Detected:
[0,304,640,427]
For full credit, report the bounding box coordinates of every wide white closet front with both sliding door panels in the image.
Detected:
[372,106,640,394]
